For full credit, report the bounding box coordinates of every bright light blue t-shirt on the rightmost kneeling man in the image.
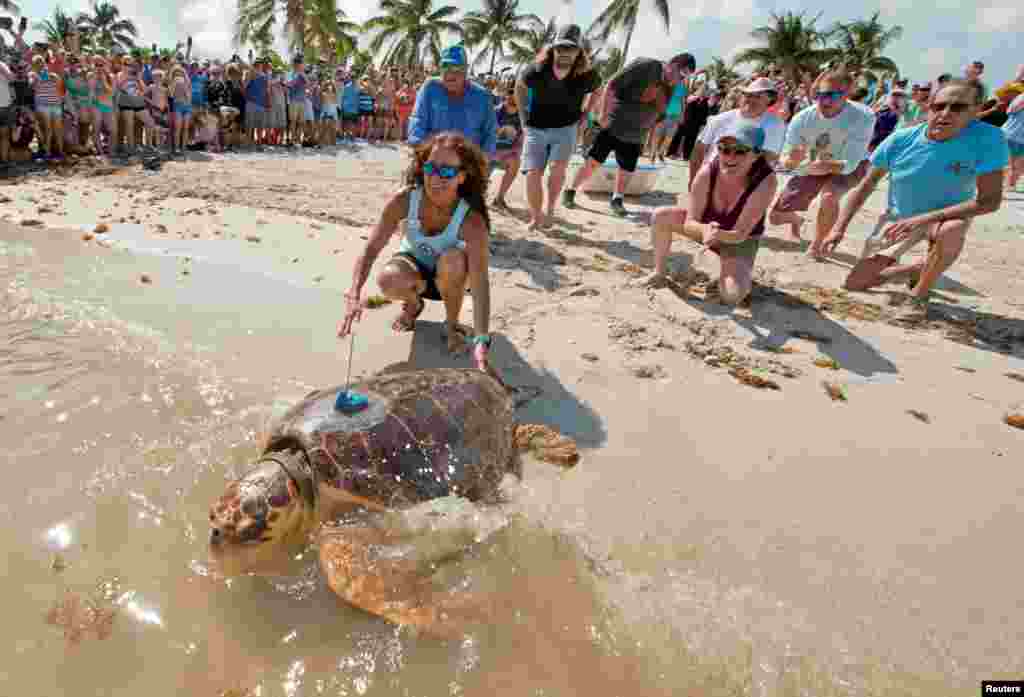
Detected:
[871,121,1010,220]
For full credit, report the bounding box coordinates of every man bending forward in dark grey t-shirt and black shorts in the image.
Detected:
[562,53,696,217]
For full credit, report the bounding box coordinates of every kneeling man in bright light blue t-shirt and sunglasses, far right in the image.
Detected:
[824,80,1010,318]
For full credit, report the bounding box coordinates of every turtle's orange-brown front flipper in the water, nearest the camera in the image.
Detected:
[319,524,488,639]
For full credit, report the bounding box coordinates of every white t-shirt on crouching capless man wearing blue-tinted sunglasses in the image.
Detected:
[782,100,874,174]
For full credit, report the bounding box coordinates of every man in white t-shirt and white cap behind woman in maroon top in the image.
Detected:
[690,78,785,186]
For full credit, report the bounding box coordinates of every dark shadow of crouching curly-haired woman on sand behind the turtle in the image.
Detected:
[381,319,607,447]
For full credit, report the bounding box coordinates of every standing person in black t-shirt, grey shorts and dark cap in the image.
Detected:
[515,25,601,229]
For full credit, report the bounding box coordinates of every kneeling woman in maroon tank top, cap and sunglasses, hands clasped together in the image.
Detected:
[647,124,777,305]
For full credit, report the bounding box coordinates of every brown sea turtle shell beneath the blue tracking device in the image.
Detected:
[265,368,514,508]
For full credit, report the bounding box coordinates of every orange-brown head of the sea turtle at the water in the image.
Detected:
[210,451,316,573]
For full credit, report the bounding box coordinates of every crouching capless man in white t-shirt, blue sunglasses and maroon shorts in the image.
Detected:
[768,71,874,252]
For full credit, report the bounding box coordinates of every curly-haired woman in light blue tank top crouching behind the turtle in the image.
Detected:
[338,133,490,369]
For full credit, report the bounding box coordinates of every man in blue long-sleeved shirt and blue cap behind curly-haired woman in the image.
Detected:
[409,46,498,158]
